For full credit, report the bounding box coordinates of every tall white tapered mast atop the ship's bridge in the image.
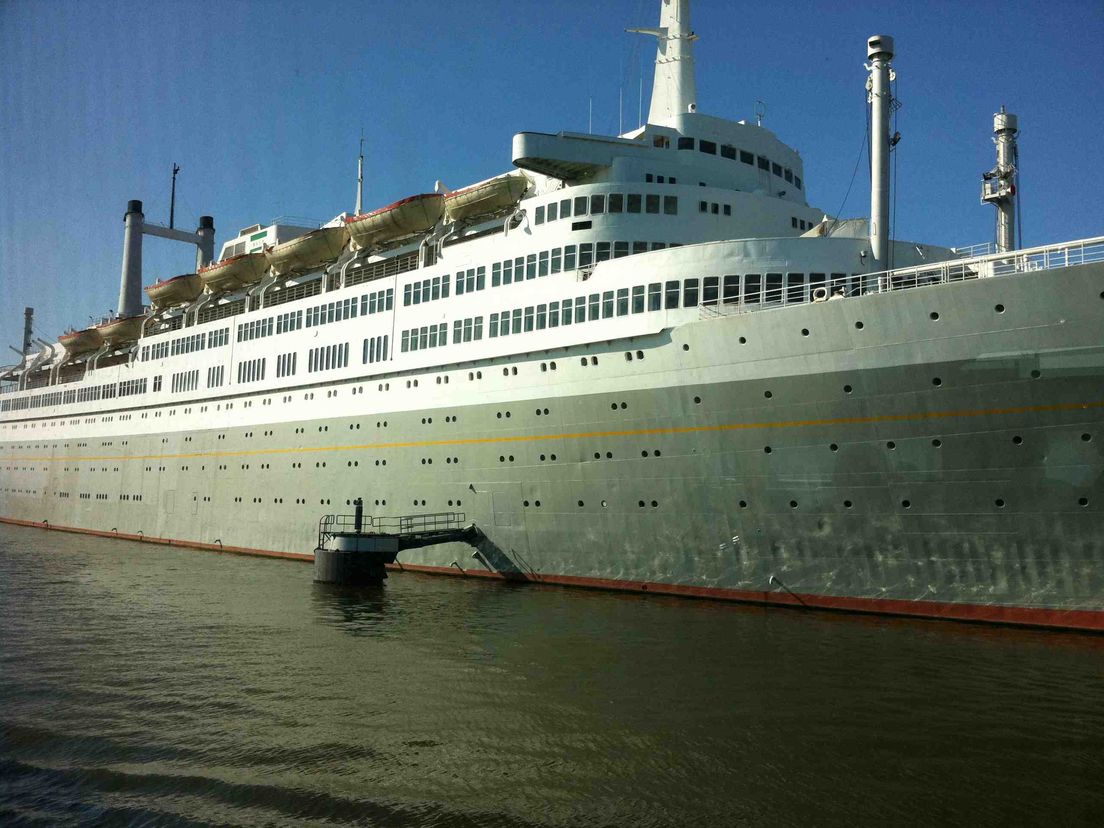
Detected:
[625,0,698,124]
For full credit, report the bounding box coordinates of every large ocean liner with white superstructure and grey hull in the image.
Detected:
[0,0,1104,629]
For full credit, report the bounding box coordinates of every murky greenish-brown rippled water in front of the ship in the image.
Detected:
[0,526,1104,828]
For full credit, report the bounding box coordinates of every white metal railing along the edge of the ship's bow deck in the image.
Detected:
[701,236,1104,318]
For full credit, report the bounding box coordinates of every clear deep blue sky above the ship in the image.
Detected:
[0,0,1104,351]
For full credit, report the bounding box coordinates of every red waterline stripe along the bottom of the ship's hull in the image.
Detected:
[0,518,1104,633]
